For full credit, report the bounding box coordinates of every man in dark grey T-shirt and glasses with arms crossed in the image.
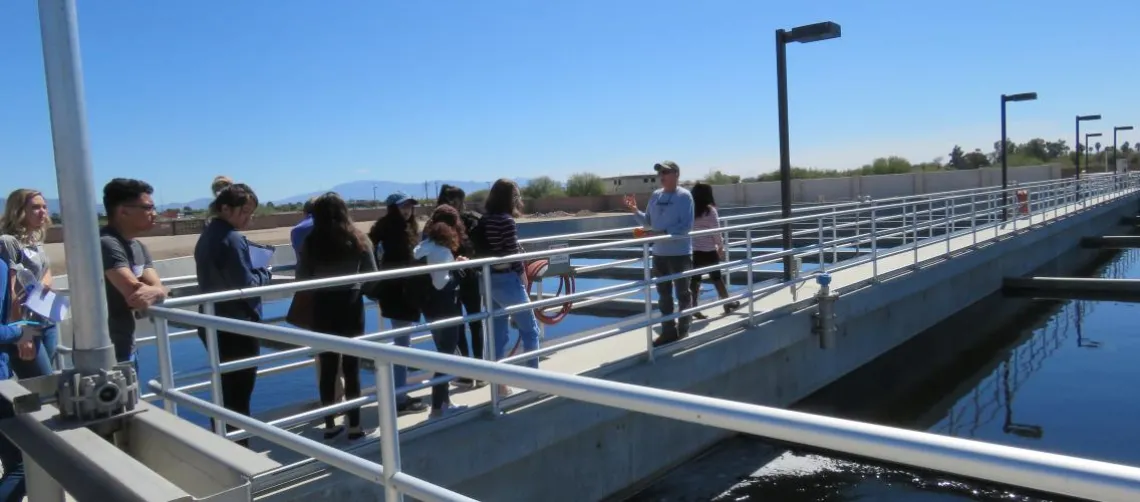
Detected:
[99,178,166,366]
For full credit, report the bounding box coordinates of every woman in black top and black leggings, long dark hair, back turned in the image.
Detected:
[296,193,376,440]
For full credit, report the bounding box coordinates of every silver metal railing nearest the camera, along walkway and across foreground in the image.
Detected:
[131,176,1140,500]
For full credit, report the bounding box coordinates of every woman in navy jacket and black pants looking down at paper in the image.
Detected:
[194,177,270,446]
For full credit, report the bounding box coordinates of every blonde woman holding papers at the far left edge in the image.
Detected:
[0,188,59,378]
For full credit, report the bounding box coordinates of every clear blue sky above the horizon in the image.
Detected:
[0,0,1140,203]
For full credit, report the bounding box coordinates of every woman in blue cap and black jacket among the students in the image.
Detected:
[368,192,428,413]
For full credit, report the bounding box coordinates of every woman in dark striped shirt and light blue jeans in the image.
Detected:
[479,179,538,396]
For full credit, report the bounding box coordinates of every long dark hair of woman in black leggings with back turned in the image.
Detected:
[301,192,369,262]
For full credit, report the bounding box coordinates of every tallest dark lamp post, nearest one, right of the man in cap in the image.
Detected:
[776,21,841,281]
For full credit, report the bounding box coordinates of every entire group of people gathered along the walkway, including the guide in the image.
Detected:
[0,161,739,495]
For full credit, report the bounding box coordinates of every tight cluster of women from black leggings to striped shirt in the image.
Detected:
[291,179,538,439]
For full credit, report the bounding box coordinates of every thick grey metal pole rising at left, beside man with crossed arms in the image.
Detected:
[39,0,115,374]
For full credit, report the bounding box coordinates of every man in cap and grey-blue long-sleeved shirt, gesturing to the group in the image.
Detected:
[625,161,693,346]
